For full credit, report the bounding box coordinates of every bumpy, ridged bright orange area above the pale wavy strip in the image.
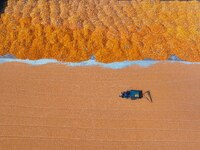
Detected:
[0,0,200,62]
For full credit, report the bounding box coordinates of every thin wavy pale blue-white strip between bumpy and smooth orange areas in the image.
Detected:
[0,58,200,69]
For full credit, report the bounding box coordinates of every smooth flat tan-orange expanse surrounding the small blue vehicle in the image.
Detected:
[0,63,200,150]
